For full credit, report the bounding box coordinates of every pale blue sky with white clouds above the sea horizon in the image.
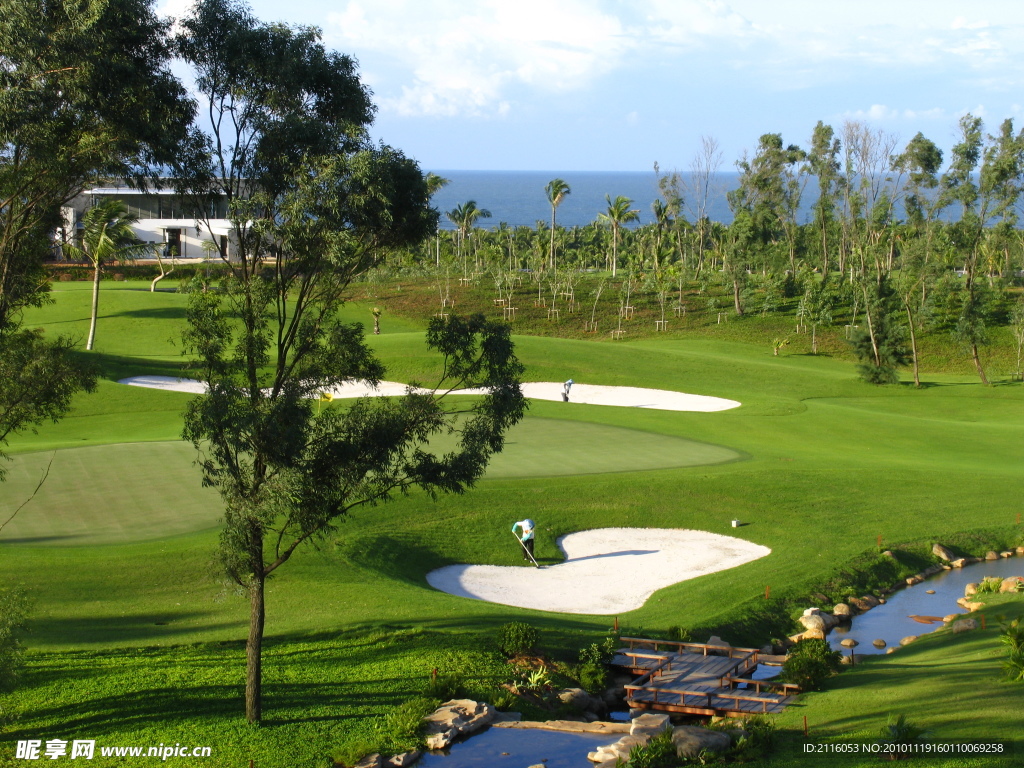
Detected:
[162,0,1024,171]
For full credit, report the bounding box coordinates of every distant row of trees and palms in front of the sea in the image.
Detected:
[413,123,1024,383]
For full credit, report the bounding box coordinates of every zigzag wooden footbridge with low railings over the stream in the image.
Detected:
[611,637,800,717]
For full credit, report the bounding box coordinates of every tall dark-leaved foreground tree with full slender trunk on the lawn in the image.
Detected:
[178,0,524,721]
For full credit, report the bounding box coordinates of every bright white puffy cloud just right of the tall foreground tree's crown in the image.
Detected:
[328,0,629,115]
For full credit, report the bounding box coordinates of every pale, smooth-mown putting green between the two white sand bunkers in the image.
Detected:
[0,418,739,546]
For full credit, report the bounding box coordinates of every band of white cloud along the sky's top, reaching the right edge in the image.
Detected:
[323,0,1024,119]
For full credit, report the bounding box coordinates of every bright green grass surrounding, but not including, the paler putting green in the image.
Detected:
[0,284,1024,765]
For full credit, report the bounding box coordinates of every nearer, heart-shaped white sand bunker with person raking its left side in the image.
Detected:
[427,528,771,615]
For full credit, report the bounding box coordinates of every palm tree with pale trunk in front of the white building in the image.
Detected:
[68,198,153,349]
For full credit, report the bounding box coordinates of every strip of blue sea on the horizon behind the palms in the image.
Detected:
[425,170,738,229]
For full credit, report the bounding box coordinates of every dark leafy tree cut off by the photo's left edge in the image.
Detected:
[0,0,184,475]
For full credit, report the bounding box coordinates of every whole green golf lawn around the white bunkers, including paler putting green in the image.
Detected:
[0,284,1024,766]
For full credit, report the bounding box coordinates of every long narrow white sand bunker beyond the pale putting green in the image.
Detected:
[118,376,740,413]
